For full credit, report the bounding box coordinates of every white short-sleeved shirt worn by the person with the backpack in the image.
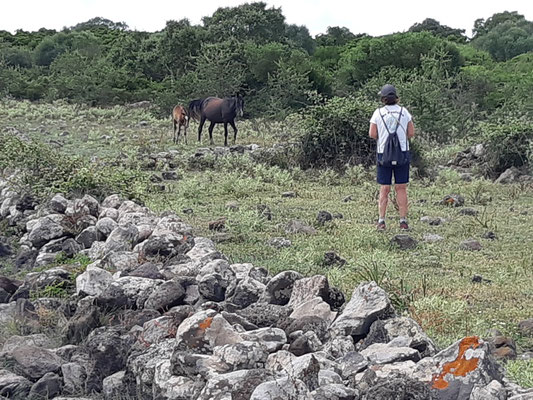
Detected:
[370,104,412,154]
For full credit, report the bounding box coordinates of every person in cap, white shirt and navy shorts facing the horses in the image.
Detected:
[368,84,415,231]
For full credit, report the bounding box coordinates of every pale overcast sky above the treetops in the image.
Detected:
[0,0,533,36]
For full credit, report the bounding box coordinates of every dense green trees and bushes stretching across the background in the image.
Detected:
[0,2,533,173]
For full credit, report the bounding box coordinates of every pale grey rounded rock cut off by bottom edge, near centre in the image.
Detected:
[250,377,313,400]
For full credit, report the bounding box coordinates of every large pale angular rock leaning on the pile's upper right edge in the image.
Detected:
[331,282,392,336]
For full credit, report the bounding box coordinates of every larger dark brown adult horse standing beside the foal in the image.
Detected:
[189,96,244,146]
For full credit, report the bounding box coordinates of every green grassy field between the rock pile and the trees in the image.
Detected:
[0,101,533,385]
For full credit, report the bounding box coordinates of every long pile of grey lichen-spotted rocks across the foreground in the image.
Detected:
[0,180,531,400]
